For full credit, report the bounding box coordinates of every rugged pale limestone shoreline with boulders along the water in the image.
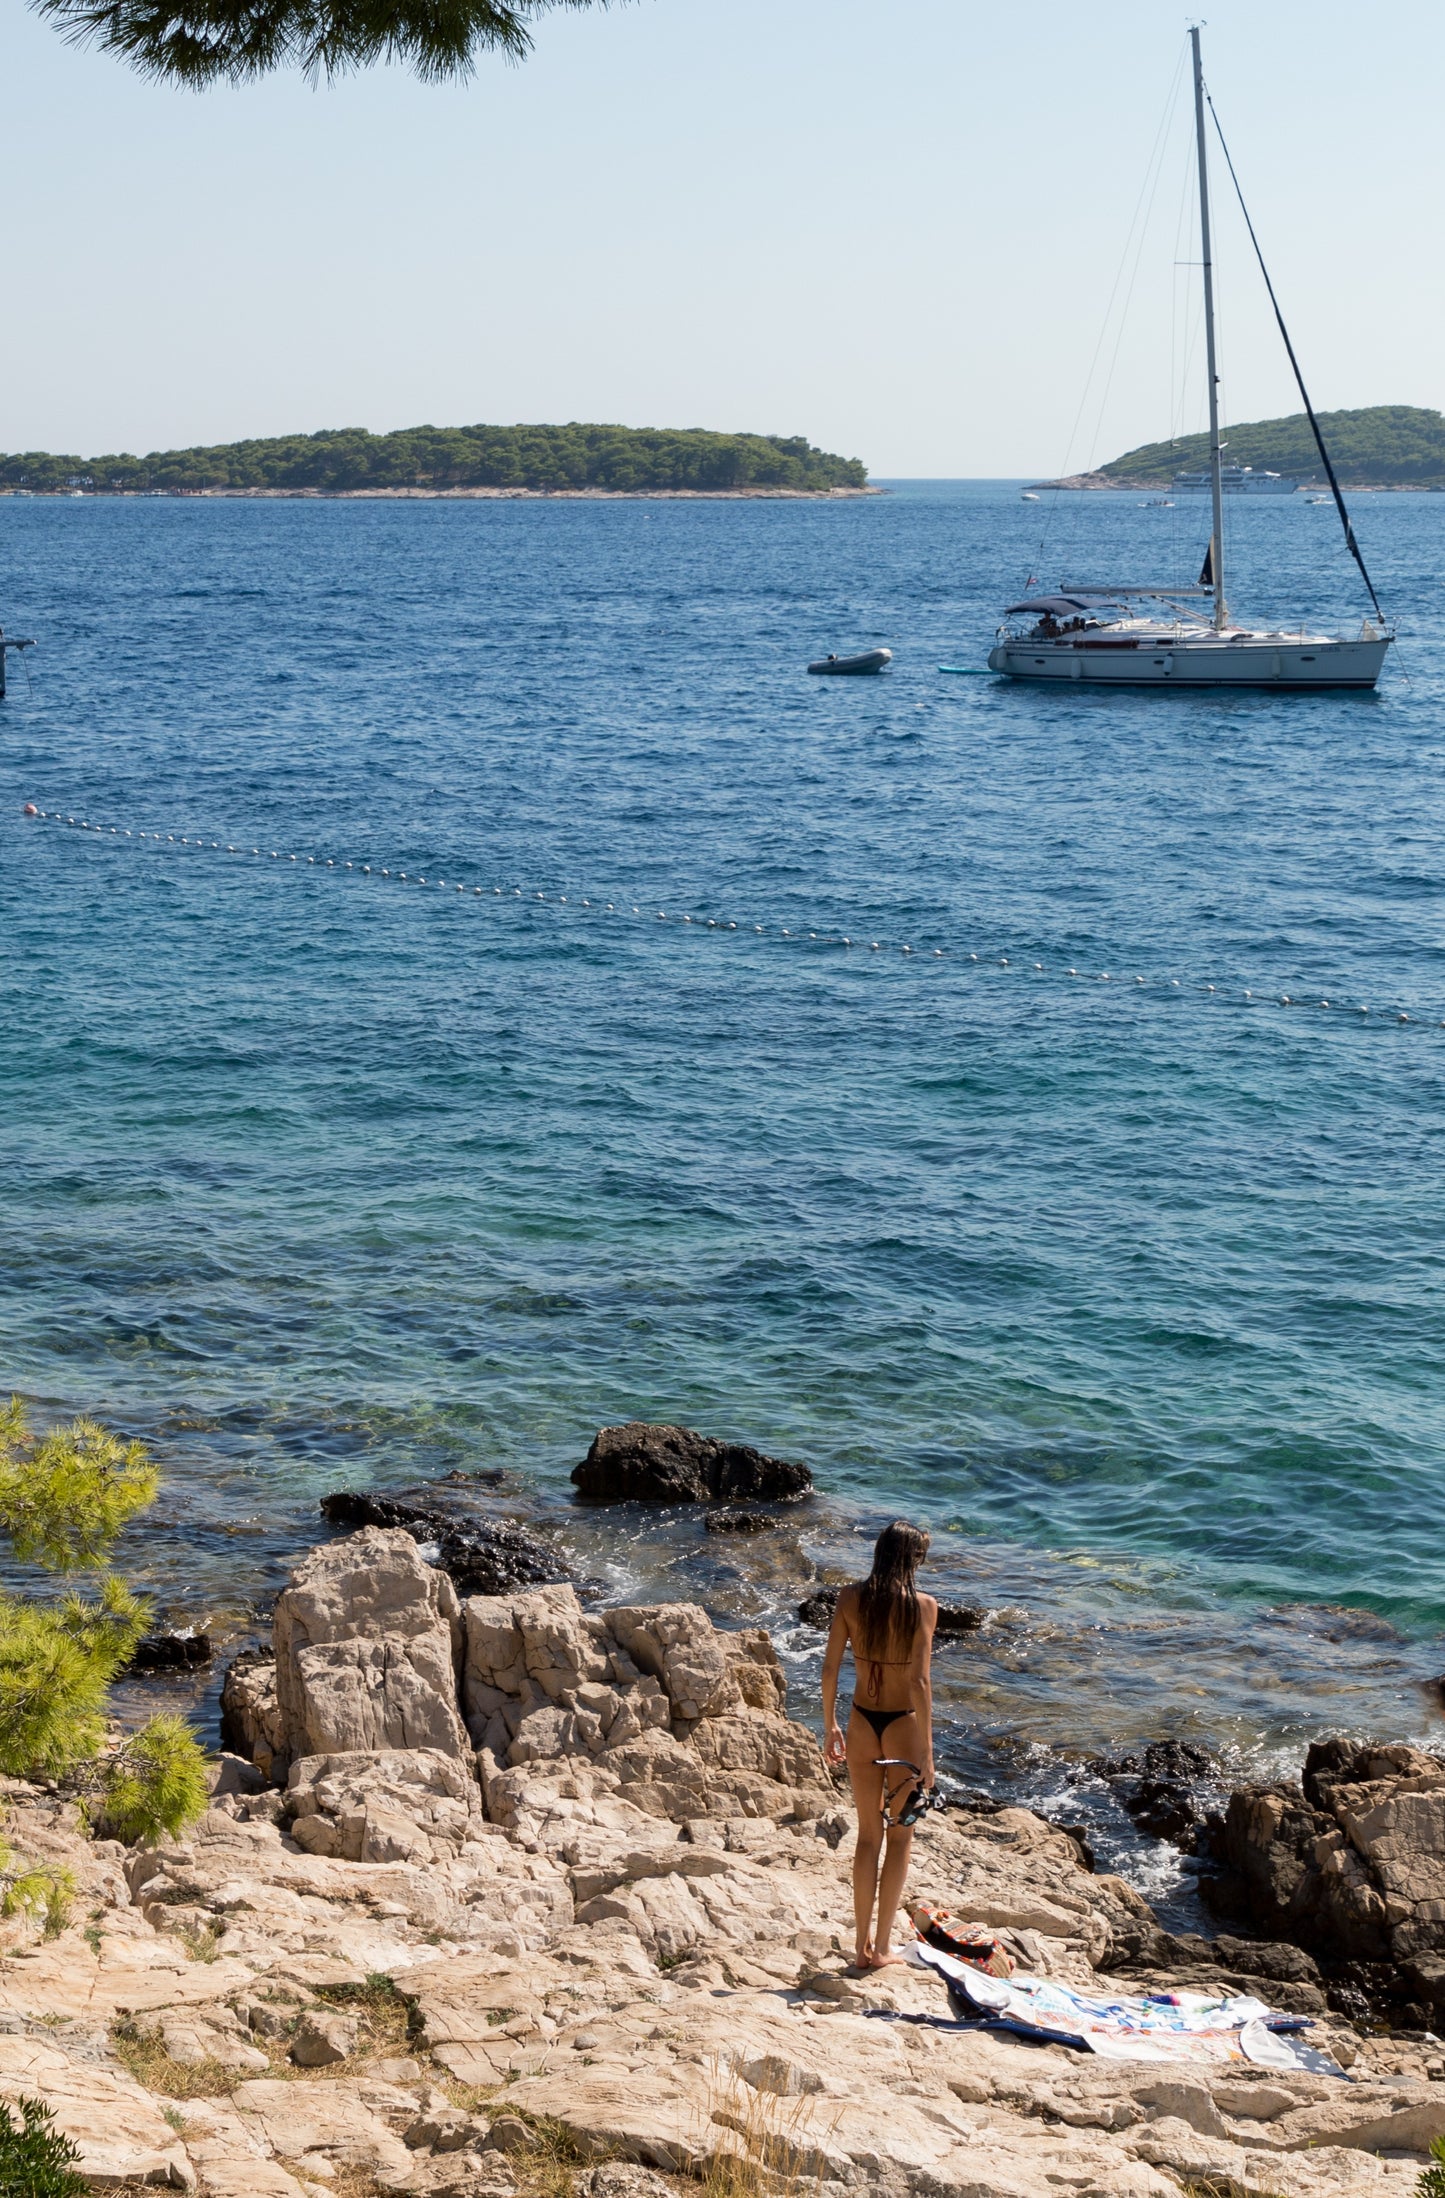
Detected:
[0,1446,1445,2198]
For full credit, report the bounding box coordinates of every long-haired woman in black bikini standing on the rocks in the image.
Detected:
[823,1519,939,1969]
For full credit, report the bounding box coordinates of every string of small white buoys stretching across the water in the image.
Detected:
[22,802,1445,1031]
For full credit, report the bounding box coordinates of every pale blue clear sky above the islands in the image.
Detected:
[0,0,1445,479]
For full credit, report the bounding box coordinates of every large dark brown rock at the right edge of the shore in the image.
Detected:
[1201,1741,1445,2027]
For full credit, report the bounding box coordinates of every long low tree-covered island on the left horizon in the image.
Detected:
[0,422,869,495]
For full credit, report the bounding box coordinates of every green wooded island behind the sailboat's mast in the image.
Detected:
[1100,404,1445,488]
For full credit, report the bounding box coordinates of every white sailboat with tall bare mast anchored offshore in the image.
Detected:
[988,26,1394,688]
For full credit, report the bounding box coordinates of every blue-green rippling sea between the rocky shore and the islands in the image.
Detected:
[0,481,1445,1899]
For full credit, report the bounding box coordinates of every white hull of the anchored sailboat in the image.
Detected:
[988,633,1390,688]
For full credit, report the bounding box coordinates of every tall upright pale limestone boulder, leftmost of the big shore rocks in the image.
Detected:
[275,1528,466,1763]
